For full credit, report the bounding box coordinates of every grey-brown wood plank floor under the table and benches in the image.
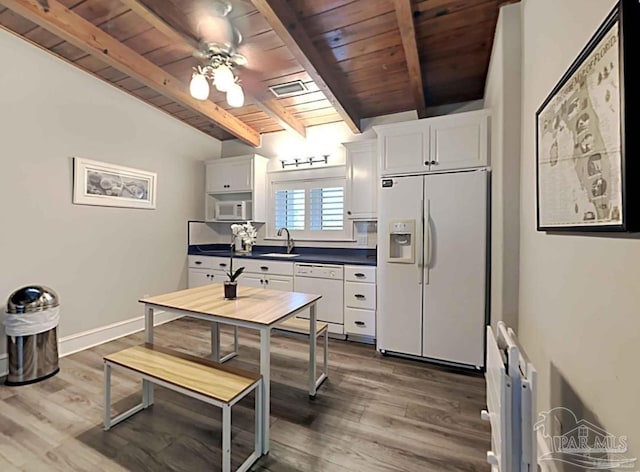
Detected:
[0,319,490,472]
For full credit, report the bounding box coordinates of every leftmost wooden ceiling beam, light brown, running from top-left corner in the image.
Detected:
[0,0,260,146]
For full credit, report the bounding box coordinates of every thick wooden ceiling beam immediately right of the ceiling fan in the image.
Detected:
[251,0,361,133]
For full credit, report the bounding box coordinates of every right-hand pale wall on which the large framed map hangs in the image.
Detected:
[519,0,640,460]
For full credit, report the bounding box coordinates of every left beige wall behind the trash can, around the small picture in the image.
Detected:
[0,30,221,353]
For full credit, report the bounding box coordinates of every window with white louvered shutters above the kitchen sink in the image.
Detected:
[269,178,350,240]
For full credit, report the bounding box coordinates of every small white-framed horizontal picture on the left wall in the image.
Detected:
[73,157,157,210]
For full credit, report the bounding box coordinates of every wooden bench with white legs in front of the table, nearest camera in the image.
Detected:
[104,344,262,472]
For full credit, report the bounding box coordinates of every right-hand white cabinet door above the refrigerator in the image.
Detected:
[431,110,489,170]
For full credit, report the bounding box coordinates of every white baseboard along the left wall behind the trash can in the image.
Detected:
[0,311,182,377]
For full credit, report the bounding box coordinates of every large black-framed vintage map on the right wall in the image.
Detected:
[536,0,640,232]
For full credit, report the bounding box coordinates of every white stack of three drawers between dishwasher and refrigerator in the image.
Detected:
[344,266,377,342]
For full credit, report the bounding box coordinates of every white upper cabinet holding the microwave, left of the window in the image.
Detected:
[205,154,269,222]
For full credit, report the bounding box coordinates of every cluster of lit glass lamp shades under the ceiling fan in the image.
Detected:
[189,54,244,108]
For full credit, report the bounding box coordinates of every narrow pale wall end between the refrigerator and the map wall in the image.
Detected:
[484,3,522,329]
